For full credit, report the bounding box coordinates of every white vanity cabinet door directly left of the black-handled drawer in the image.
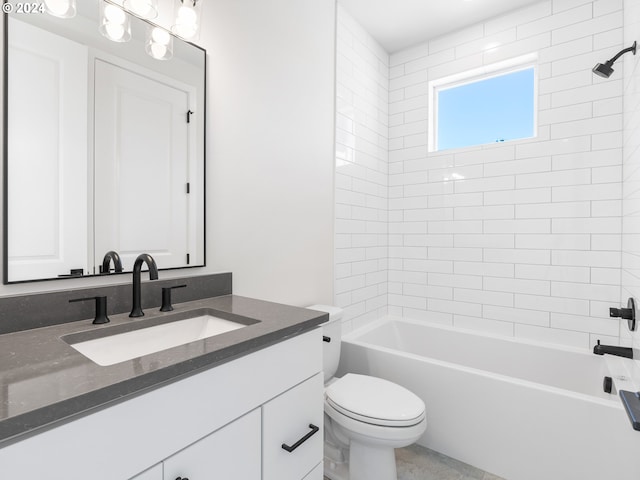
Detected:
[163,408,261,480]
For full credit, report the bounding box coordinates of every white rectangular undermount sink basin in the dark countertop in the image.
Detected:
[69,314,247,366]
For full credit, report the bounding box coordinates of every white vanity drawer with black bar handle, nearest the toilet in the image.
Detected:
[262,373,324,480]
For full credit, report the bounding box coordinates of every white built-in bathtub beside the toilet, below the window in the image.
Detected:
[339,318,640,480]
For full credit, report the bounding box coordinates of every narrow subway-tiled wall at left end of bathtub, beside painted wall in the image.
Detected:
[335,7,389,331]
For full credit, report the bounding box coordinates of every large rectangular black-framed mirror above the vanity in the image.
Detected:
[4,1,206,284]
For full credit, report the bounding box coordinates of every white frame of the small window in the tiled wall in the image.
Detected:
[427,53,538,152]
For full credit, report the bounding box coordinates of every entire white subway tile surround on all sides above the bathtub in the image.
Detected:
[336,0,628,348]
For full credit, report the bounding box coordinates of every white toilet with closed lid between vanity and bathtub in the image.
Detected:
[307,305,427,480]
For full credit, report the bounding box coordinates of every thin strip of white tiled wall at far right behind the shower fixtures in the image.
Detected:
[620,0,640,356]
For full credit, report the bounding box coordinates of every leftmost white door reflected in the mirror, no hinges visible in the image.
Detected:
[7,18,93,282]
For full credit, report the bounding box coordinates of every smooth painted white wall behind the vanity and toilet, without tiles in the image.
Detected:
[0,0,335,305]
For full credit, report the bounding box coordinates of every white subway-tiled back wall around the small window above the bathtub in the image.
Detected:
[389,0,623,348]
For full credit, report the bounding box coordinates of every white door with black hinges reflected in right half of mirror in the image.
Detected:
[94,59,189,273]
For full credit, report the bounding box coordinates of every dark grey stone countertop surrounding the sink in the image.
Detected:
[0,295,328,448]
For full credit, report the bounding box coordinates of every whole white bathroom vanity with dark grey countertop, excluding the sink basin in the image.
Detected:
[0,284,326,480]
